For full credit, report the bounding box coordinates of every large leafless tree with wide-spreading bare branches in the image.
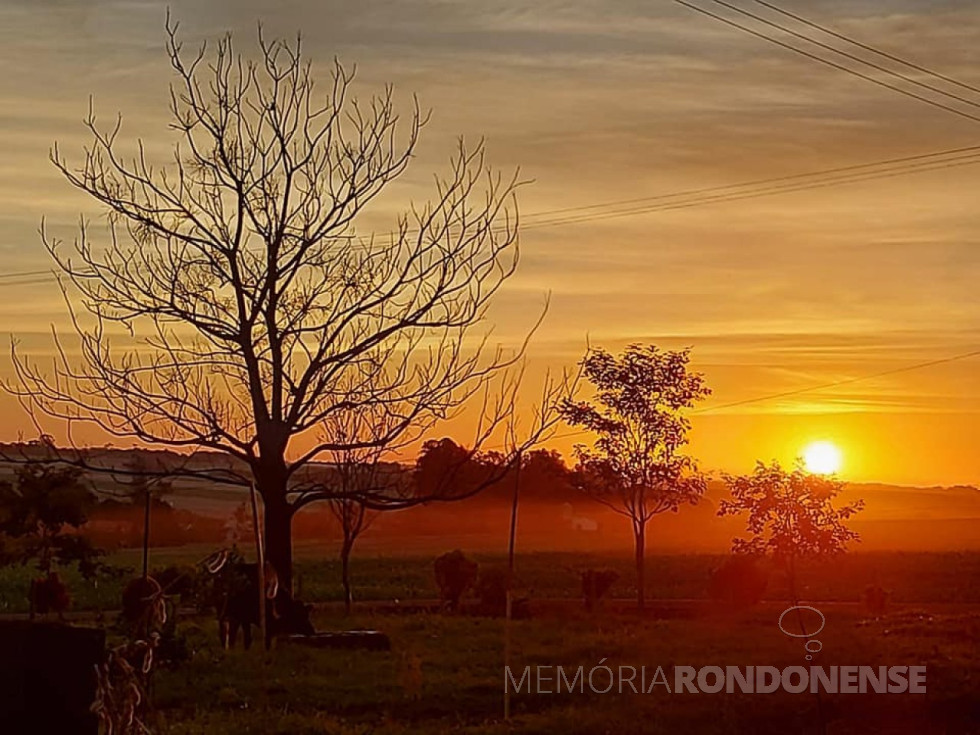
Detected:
[5,18,568,589]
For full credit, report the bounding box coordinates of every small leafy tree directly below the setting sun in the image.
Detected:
[718,461,864,605]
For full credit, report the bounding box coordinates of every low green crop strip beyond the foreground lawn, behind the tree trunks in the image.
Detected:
[0,545,980,613]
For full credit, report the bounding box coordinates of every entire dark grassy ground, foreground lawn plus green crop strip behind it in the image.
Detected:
[0,547,980,735]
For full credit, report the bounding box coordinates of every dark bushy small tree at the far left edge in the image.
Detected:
[0,465,102,615]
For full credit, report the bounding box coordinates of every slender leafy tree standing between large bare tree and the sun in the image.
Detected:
[562,344,710,610]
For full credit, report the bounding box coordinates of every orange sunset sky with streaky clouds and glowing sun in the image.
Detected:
[0,0,980,484]
